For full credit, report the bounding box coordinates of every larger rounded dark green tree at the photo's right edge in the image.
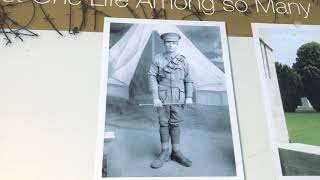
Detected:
[293,42,320,111]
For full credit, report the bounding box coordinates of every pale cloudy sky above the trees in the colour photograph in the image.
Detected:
[268,28,320,66]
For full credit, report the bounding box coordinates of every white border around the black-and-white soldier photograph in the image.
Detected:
[95,17,244,180]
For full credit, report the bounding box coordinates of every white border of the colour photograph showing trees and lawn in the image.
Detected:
[251,23,320,180]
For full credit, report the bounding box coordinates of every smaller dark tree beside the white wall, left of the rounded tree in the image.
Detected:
[275,62,303,112]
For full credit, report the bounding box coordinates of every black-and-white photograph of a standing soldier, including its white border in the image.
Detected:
[101,18,244,180]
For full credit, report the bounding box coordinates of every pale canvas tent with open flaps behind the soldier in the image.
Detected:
[108,24,227,105]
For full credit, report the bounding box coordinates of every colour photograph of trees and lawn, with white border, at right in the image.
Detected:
[253,24,320,177]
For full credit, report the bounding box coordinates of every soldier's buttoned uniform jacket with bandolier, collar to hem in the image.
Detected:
[149,53,193,103]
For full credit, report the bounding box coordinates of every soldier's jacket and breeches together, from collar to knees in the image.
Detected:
[149,53,193,126]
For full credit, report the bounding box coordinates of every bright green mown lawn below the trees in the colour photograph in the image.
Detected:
[285,113,320,146]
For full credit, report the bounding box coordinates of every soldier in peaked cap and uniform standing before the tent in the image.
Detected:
[148,33,193,168]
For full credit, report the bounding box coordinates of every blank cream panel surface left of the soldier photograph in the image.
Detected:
[0,31,102,180]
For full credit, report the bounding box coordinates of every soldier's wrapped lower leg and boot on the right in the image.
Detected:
[170,125,192,167]
